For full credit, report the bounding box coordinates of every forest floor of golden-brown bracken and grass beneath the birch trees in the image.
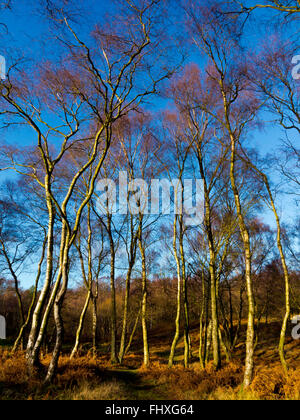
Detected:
[0,323,300,400]
